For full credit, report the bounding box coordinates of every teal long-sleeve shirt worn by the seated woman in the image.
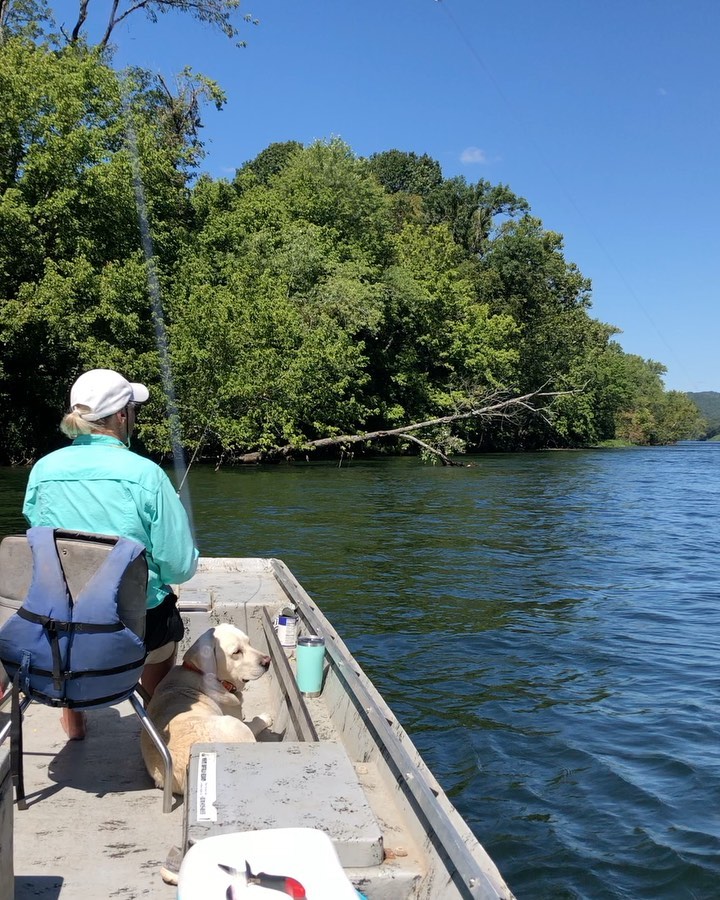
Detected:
[23,434,198,608]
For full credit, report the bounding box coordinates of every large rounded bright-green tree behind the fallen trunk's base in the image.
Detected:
[170,141,389,451]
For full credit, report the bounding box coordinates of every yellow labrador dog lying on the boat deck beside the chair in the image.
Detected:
[140,623,272,794]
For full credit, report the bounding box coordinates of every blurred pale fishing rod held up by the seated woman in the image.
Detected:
[125,101,195,534]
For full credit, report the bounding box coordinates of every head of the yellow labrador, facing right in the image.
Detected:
[183,622,270,691]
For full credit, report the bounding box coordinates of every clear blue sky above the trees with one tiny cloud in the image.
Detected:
[52,0,720,391]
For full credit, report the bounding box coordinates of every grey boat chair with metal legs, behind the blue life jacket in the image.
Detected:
[0,529,173,813]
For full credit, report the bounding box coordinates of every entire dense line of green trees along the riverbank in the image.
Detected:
[0,10,701,462]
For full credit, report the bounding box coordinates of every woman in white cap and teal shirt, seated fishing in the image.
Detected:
[23,369,198,740]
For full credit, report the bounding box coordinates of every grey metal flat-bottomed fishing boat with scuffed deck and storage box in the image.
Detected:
[0,560,512,900]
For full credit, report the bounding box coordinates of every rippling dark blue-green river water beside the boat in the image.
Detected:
[0,443,720,900]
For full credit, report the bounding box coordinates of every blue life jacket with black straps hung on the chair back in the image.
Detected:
[0,527,146,708]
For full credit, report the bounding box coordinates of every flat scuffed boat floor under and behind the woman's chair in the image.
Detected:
[14,703,183,900]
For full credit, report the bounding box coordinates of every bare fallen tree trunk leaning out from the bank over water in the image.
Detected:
[226,388,577,466]
